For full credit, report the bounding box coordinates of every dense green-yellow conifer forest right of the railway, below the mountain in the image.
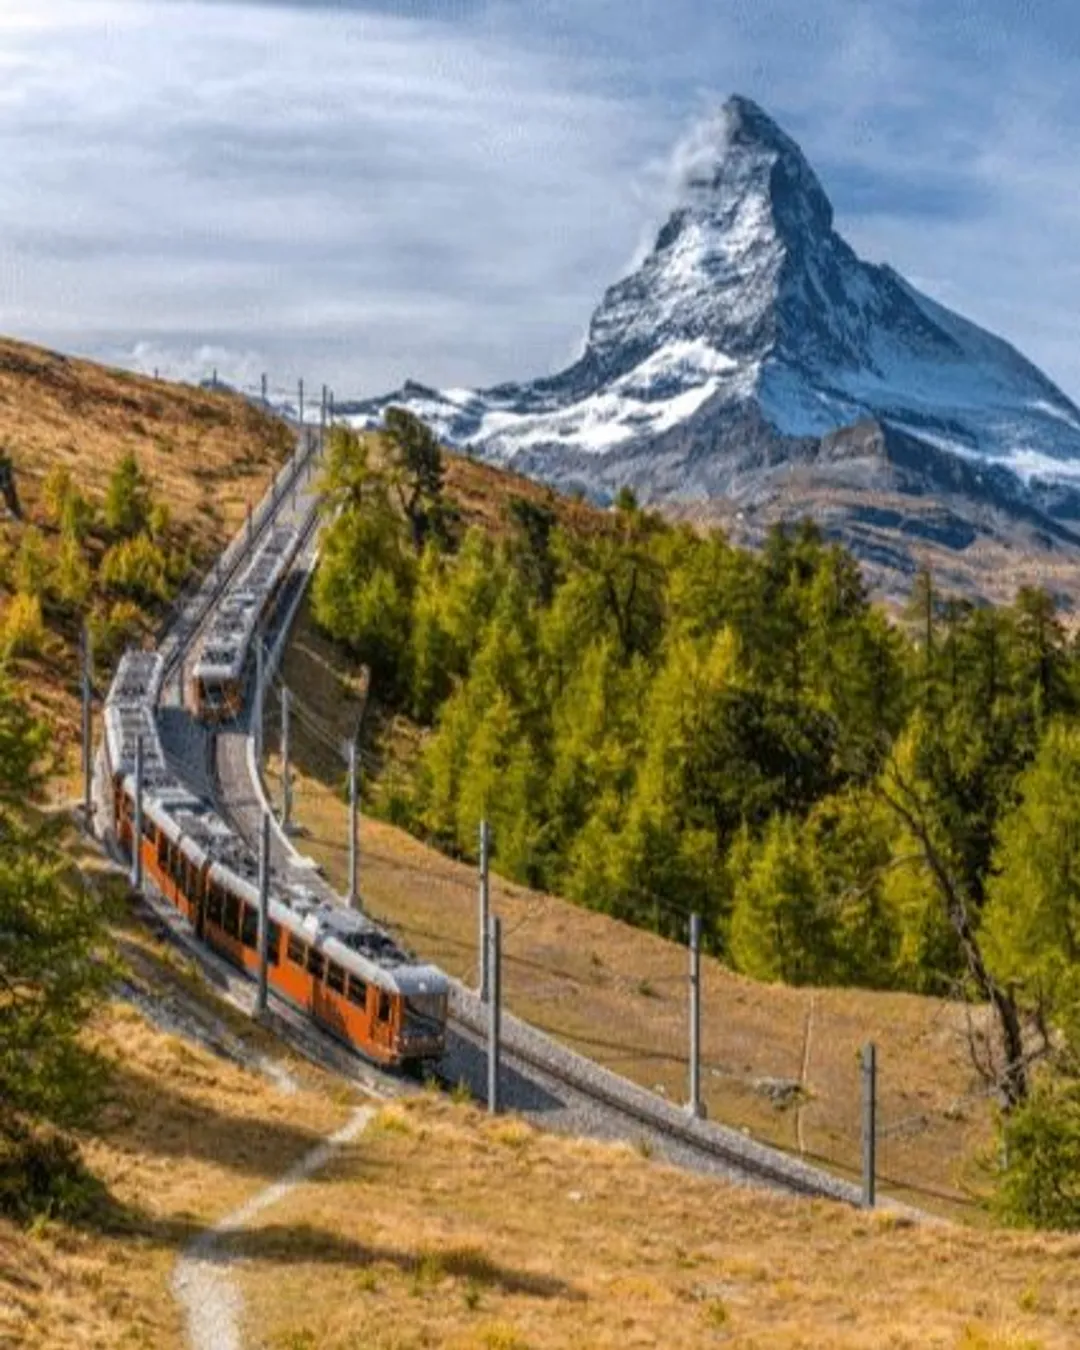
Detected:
[313,409,1080,1227]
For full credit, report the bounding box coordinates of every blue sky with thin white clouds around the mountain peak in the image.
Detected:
[0,0,1080,400]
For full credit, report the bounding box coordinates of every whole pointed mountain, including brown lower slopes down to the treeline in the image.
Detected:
[342,97,1080,595]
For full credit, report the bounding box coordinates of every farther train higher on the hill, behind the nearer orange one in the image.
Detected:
[188,525,300,722]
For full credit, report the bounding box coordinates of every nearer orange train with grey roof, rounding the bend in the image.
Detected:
[105,652,450,1067]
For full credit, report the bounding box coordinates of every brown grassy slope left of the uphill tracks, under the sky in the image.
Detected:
[0,330,292,788]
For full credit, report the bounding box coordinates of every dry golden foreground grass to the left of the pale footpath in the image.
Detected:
[0,926,351,1350]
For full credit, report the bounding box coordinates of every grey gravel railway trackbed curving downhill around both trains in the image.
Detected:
[114,415,860,1204]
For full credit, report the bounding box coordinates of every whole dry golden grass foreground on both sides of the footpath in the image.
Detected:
[0,896,1080,1350]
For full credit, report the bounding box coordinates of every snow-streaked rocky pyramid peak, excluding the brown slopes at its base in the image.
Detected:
[352,96,1080,553]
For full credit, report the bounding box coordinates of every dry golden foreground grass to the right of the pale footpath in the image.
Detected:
[238,1099,1080,1350]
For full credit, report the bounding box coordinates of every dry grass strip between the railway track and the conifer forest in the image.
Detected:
[269,609,992,1216]
